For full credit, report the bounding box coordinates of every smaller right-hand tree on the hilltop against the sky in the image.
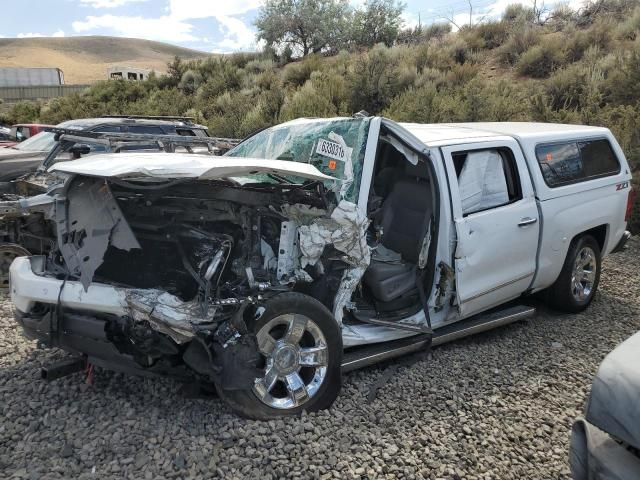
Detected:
[352,0,405,47]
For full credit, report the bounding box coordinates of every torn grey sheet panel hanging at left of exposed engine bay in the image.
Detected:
[55,178,140,291]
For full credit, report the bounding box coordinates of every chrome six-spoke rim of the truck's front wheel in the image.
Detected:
[253,313,328,409]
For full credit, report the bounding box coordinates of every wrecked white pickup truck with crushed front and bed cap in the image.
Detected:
[10,117,632,418]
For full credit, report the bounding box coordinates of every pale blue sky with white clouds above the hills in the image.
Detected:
[0,0,583,53]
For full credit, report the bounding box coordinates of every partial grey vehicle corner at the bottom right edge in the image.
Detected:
[569,332,640,480]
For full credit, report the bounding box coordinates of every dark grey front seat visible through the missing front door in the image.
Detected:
[364,177,432,302]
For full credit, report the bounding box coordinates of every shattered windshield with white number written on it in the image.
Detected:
[226,118,371,201]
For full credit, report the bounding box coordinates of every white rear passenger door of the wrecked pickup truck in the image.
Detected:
[442,138,539,318]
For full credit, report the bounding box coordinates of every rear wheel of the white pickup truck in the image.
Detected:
[548,235,601,313]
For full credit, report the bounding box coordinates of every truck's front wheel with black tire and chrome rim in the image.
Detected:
[217,293,342,419]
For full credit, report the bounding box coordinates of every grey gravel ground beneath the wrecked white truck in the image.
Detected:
[0,240,640,479]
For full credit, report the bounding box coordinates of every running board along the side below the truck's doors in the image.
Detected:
[342,305,536,372]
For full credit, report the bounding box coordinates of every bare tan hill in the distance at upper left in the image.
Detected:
[0,36,208,84]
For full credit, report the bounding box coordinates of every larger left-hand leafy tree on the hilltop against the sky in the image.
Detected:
[255,0,351,56]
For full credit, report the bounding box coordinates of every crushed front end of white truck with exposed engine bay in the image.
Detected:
[10,158,368,412]
